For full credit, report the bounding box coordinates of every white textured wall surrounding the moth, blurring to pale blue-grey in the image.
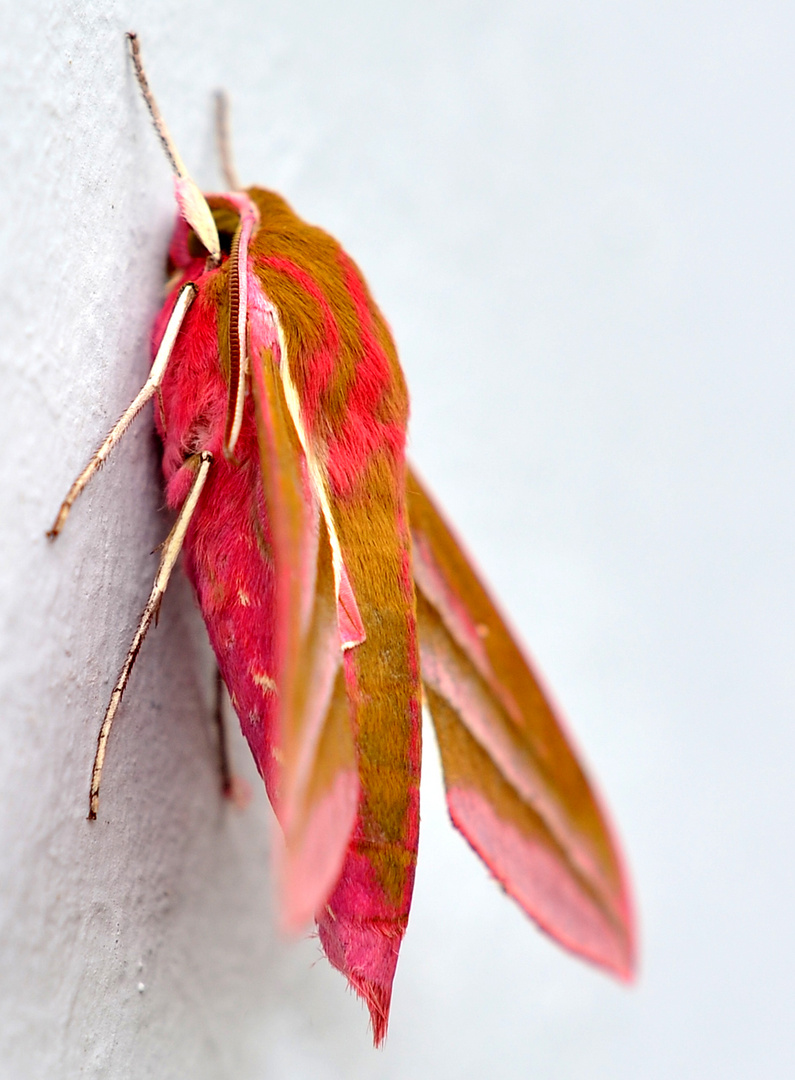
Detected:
[0,0,795,1080]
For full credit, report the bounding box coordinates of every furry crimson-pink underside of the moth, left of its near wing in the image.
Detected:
[154,278,278,799]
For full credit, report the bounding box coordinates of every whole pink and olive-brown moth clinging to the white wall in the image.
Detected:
[51,35,634,1044]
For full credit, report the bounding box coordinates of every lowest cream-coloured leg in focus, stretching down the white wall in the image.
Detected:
[89,450,213,821]
